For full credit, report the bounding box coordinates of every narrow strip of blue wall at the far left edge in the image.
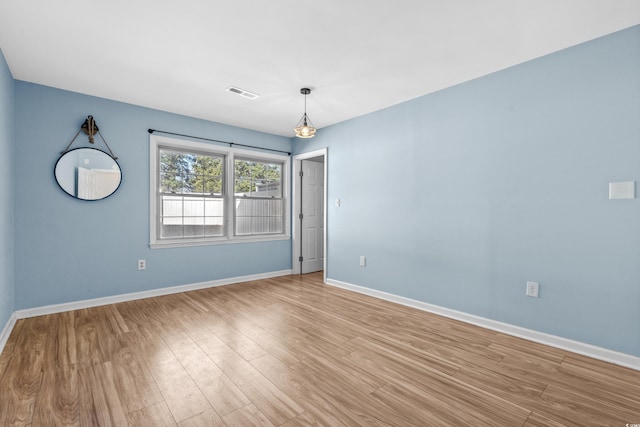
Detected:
[0,50,15,332]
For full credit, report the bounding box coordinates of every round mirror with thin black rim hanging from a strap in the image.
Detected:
[54,148,122,200]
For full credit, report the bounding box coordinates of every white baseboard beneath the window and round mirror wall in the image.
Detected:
[14,270,291,319]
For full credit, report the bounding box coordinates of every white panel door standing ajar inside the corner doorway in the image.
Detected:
[300,160,324,274]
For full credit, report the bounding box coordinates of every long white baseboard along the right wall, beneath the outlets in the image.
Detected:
[326,278,640,371]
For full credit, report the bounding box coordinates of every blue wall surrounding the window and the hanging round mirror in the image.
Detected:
[13,81,291,309]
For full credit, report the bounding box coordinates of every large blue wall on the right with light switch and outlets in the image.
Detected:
[294,26,640,356]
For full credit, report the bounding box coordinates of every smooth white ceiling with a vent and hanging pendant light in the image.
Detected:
[0,0,640,136]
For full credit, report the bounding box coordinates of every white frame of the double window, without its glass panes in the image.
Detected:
[149,135,291,249]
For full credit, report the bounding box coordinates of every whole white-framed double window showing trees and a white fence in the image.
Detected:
[150,135,289,247]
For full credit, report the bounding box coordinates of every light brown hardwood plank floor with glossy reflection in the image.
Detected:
[0,274,640,427]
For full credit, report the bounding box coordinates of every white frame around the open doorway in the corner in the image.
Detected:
[291,147,329,283]
